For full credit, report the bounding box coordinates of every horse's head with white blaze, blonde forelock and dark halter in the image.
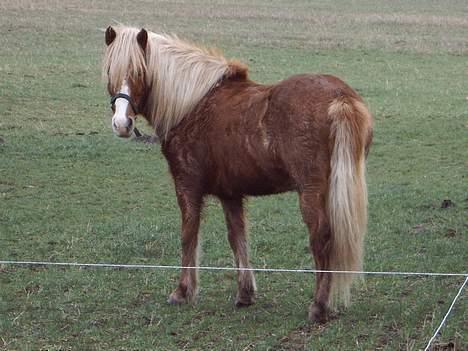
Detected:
[104,27,148,138]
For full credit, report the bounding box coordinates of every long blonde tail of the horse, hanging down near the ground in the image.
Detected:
[327,97,372,305]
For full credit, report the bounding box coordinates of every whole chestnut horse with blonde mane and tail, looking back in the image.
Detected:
[103,26,372,321]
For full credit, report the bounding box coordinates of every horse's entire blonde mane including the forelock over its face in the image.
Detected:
[103,27,247,138]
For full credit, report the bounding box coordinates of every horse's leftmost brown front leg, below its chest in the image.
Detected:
[168,187,202,304]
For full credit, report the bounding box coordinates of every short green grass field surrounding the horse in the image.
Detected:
[0,0,468,350]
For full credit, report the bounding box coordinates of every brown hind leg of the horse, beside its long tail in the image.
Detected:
[299,190,331,323]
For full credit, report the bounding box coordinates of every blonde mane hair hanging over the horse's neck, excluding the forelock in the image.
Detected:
[147,37,229,136]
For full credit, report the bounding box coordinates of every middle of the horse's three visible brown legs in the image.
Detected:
[221,199,256,307]
